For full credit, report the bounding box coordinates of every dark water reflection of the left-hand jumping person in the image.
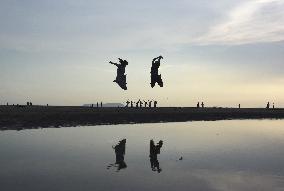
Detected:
[107,139,127,172]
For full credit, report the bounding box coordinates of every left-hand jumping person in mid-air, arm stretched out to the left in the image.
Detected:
[109,58,128,90]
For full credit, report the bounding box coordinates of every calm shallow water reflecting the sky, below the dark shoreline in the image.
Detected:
[0,120,284,191]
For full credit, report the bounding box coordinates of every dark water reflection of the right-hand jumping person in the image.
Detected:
[149,140,163,173]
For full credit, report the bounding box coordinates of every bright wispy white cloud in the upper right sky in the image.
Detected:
[195,0,284,45]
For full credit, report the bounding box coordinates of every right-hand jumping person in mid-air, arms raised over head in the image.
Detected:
[151,56,164,88]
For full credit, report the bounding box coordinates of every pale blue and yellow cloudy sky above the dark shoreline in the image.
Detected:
[0,0,284,107]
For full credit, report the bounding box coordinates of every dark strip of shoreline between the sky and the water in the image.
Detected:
[0,106,284,130]
